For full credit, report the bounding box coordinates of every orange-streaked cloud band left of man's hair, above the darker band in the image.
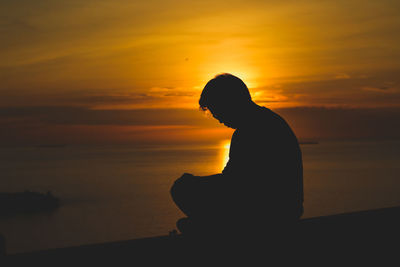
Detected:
[0,87,200,109]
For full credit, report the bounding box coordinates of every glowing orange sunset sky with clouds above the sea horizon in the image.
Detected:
[0,0,400,144]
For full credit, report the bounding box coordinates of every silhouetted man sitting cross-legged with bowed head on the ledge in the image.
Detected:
[171,74,303,237]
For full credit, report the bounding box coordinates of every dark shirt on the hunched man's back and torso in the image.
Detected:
[222,107,303,219]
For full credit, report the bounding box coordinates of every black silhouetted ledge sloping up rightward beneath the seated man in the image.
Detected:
[0,207,400,266]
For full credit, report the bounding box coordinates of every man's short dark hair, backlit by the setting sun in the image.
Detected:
[199,73,251,110]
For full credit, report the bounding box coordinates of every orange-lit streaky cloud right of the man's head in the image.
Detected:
[254,70,400,108]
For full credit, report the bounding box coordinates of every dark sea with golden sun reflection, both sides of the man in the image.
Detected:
[0,141,400,253]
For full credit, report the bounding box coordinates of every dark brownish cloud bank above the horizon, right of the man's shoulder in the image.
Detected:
[277,107,400,139]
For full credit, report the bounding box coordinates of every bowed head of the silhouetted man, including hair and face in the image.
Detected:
[199,73,253,128]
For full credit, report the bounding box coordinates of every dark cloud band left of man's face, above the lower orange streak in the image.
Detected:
[0,106,218,127]
